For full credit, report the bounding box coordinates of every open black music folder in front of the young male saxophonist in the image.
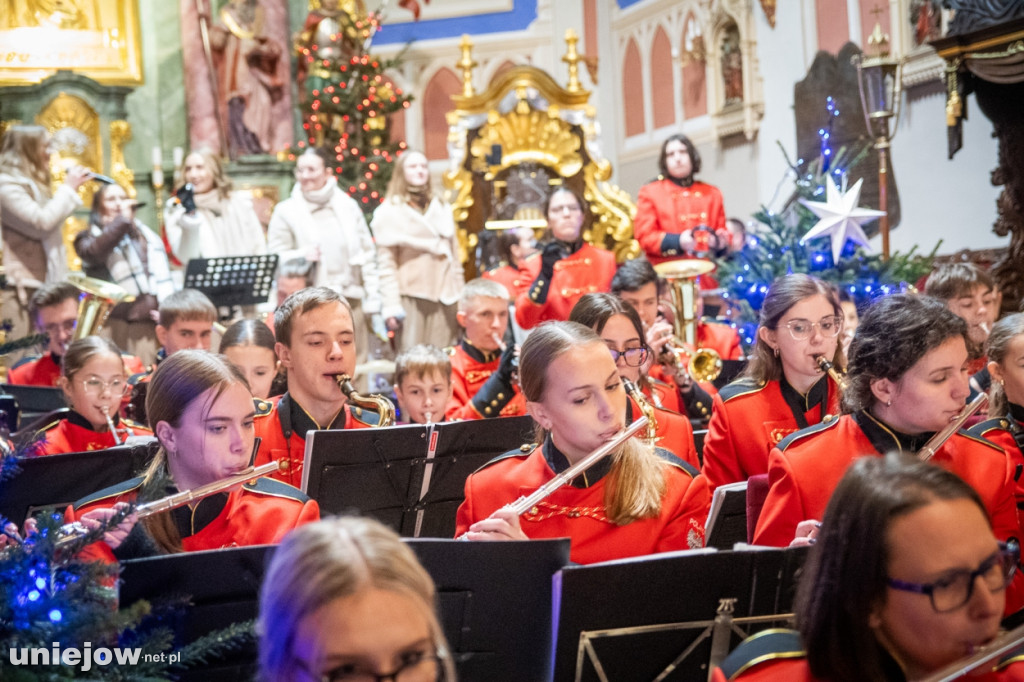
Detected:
[302,417,534,538]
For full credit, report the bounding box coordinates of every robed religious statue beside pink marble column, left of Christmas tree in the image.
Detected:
[210,0,284,158]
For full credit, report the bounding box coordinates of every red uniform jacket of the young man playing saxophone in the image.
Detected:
[255,392,378,487]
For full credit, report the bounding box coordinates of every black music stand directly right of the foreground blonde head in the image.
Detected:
[406,536,569,682]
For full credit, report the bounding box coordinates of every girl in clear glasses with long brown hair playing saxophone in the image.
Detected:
[703,274,844,491]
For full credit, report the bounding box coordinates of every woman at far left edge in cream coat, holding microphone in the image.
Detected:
[0,125,89,338]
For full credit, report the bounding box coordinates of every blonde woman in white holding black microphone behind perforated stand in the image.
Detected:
[164,148,266,263]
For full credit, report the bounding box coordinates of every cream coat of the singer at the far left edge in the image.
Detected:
[0,172,82,294]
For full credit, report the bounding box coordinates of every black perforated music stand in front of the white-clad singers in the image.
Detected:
[184,253,278,307]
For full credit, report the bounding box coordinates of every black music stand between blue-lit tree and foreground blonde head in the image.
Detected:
[120,545,274,682]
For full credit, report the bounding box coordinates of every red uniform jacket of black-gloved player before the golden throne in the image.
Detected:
[515,243,615,329]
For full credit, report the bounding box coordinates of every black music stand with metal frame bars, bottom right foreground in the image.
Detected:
[554,548,806,682]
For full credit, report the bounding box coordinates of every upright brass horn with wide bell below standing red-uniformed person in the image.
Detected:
[654,258,722,381]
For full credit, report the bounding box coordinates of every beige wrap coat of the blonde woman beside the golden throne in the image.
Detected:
[371,197,465,317]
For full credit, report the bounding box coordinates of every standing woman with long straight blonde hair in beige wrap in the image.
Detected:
[370,152,465,350]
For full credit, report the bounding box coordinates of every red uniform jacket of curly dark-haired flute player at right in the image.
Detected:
[754,412,1024,614]
